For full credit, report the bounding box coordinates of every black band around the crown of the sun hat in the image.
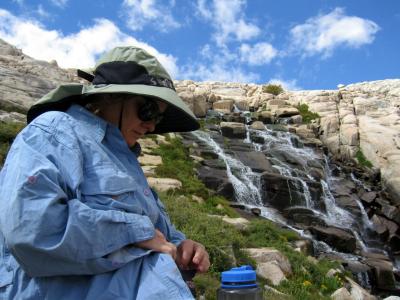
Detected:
[92,61,175,91]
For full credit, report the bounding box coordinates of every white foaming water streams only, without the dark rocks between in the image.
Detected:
[193,117,388,259]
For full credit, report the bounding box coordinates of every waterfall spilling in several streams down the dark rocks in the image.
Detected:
[193,114,396,276]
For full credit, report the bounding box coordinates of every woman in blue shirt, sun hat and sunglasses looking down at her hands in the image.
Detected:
[0,47,209,300]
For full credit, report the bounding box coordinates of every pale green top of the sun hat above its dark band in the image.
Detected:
[95,46,172,80]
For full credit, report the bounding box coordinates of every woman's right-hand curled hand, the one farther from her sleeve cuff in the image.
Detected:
[176,240,210,273]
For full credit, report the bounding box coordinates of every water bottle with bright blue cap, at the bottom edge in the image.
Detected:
[217,266,262,300]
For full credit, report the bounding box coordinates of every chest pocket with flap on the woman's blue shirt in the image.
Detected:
[80,165,143,214]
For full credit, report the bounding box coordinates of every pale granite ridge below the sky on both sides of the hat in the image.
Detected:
[0,40,400,205]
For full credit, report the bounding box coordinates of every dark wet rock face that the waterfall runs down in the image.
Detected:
[184,114,399,291]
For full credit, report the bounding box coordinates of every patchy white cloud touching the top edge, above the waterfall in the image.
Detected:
[197,0,261,46]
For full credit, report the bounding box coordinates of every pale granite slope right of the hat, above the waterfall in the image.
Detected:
[176,79,400,205]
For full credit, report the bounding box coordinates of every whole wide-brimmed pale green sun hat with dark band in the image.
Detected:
[27,47,200,133]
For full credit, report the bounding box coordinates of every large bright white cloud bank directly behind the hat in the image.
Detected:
[0,9,178,77]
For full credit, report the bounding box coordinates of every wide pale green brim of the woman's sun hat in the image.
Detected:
[27,84,200,134]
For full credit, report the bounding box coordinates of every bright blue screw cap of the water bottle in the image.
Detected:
[221,266,257,289]
